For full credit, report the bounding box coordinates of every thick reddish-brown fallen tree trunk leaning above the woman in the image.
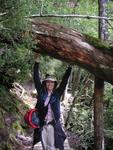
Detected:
[32,20,113,84]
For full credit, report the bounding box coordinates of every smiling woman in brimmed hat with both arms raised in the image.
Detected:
[33,55,71,150]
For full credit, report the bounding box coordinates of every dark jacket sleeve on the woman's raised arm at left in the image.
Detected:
[34,62,42,94]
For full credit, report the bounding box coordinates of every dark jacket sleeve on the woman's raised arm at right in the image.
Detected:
[57,67,72,96]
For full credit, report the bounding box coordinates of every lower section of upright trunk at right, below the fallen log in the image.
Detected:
[94,78,104,150]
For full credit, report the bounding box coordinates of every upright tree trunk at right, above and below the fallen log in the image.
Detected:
[94,0,108,150]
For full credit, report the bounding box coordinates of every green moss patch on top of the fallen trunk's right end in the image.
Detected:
[84,34,113,55]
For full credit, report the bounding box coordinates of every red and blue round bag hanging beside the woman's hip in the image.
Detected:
[24,108,40,129]
